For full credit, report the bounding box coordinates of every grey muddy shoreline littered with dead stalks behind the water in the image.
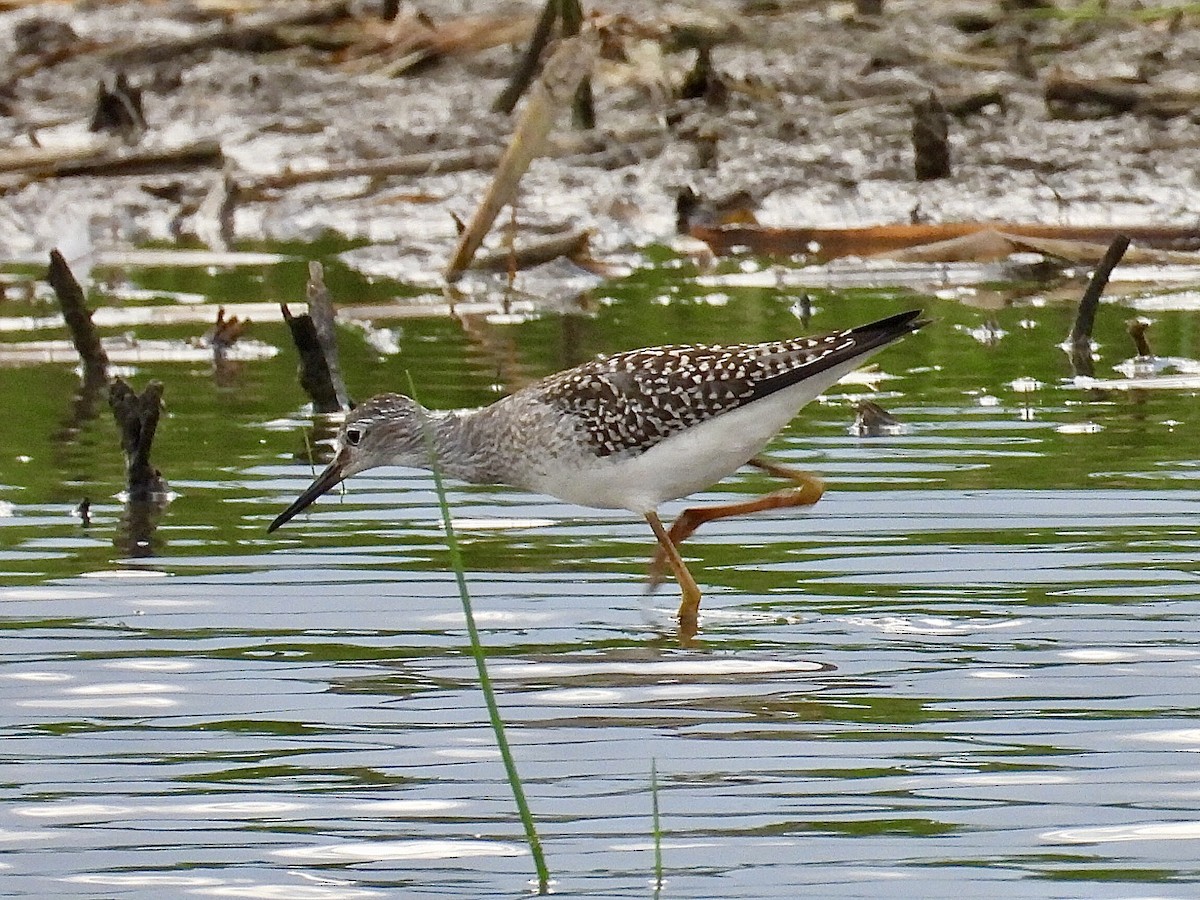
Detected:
[0,0,1200,283]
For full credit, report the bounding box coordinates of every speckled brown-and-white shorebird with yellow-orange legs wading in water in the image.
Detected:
[268,310,926,636]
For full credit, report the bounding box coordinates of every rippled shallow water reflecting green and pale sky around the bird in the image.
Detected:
[0,255,1200,899]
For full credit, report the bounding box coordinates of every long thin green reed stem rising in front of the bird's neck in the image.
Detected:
[406,373,550,894]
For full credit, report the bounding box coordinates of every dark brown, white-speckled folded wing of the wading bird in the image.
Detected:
[535,311,925,456]
